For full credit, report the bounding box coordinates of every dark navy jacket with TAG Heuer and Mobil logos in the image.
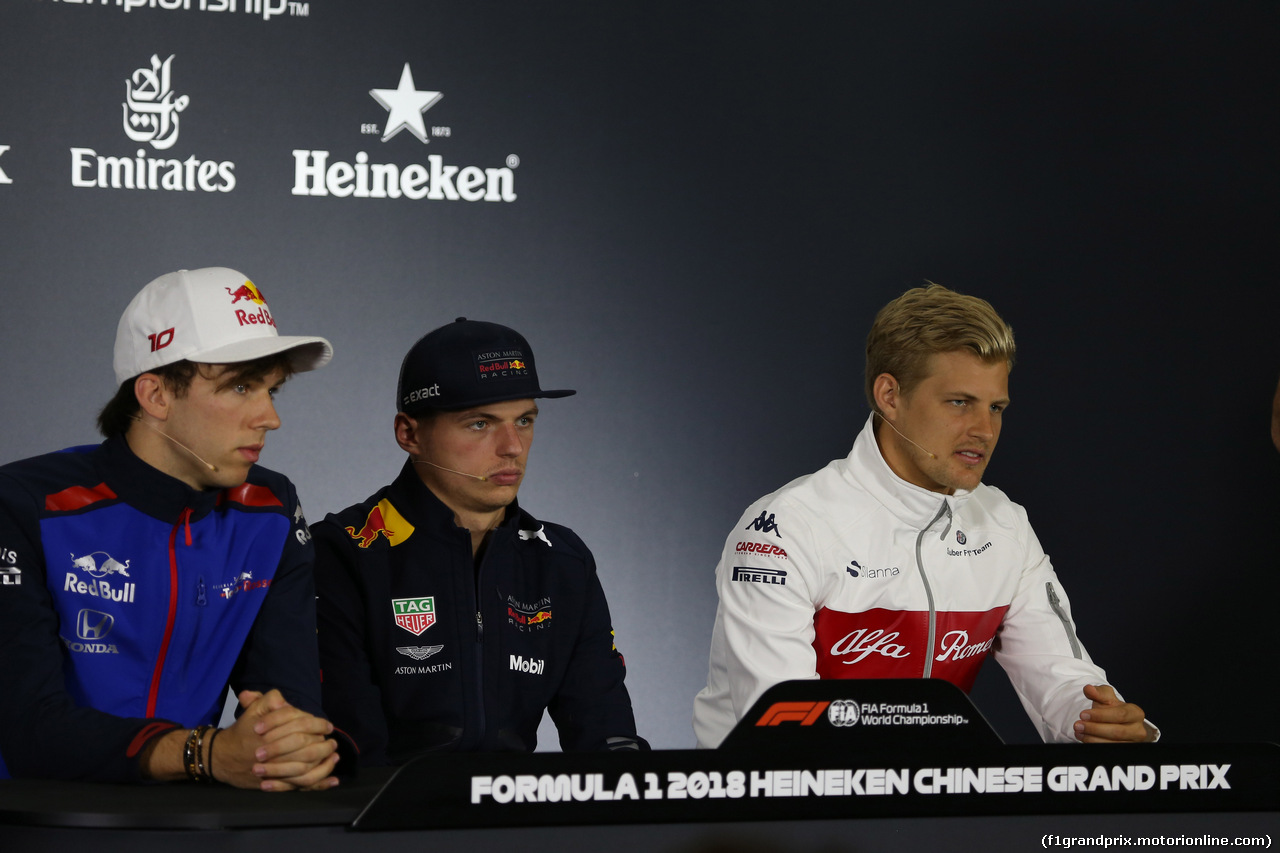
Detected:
[312,464,648,765]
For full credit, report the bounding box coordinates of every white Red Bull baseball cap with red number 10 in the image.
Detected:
[113,266,333,384]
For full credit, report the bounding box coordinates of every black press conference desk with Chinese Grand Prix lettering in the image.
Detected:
[0,744,1280,853]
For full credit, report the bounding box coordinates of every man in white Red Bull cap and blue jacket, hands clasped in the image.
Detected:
[0,268,353,790]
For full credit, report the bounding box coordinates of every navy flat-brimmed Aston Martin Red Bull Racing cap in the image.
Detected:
[396,316,577,415]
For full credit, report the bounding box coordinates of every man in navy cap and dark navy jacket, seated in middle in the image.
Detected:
[312,318,648,765]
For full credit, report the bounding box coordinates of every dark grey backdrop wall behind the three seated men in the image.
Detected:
[0,0,1280,748]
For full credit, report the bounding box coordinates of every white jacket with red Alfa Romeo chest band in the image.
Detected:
[694,419,1131,748]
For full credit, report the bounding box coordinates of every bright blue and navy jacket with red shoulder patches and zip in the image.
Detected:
[0,437,335,781]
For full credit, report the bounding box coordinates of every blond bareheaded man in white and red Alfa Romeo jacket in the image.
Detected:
[694,284,1158,747]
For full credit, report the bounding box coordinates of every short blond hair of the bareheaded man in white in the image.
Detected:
[865,282,1016,410]
